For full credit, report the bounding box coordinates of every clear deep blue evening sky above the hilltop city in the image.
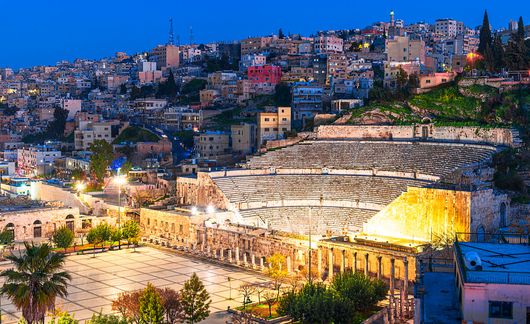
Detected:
[0,0,530,68]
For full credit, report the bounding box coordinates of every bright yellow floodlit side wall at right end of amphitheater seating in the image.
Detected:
[364,187,471,241]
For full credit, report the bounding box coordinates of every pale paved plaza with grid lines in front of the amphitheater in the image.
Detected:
[0,247,267,323]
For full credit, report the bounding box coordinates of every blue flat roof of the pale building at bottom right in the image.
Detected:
[457,242,530,285]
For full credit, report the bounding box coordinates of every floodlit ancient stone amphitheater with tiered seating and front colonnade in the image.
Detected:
[141,125,519,287]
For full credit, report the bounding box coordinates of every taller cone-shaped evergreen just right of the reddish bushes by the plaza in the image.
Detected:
[180,272,211,324]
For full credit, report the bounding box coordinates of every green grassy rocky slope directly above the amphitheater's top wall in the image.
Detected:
[348,83,530,127]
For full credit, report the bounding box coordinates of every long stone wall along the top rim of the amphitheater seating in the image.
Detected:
[316,124,518,146]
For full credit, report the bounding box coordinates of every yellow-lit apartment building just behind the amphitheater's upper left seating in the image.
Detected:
[257,107,291,146]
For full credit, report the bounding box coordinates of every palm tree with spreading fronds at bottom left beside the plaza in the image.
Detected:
[0,242,71,324]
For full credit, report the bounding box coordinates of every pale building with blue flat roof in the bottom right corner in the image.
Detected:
[455,239,530,324]
